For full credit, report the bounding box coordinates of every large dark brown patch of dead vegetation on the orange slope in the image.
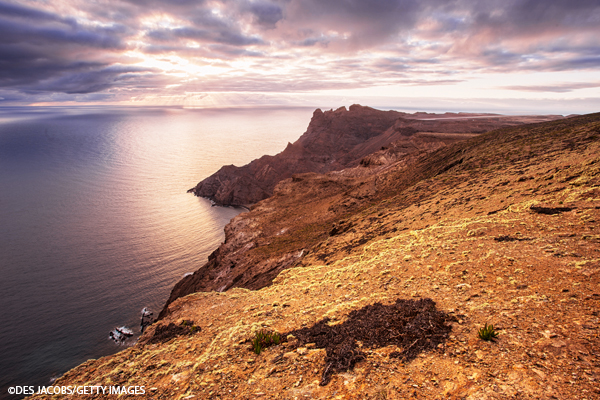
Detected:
[288,299,455,386]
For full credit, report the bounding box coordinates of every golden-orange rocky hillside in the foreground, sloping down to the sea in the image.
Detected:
[36,110,600,399]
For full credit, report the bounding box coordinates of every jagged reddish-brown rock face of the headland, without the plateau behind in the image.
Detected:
[190,105,402,206]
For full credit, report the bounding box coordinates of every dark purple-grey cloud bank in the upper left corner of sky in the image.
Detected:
[0,2,135,97]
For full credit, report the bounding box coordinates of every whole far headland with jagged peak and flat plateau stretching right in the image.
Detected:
[189,104,558,206]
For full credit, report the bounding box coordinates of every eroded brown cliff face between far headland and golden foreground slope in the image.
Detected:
[159,173,356,319]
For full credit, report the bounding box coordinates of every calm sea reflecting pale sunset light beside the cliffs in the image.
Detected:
[0,107,312,398]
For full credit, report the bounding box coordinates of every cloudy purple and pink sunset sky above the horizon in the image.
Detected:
[0,0,600,114]
